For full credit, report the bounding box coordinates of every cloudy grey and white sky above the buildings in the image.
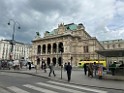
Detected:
[0,0,124,43]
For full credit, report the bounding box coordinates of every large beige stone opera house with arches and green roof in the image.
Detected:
[31,23,104,66]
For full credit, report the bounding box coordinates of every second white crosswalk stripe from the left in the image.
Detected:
[23,84,58,93]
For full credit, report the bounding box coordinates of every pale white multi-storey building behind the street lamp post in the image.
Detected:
[0,40,31,60]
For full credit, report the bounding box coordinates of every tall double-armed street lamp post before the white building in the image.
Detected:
[8,19,20,60]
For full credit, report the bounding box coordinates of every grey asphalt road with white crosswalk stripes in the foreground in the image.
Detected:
[0,72,124,93]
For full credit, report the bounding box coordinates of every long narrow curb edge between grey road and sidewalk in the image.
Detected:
[1,71,124,91]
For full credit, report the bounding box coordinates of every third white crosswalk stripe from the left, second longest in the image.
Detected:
[36,82,86,93]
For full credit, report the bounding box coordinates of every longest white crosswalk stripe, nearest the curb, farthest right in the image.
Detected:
[48,81,108,93]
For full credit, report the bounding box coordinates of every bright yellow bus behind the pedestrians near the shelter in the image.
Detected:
[78,60,106,67]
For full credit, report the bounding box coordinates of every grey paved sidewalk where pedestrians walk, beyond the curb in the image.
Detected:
[0,69,124,90]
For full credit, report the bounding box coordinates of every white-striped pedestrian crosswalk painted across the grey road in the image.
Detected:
[4,81,108,93]
